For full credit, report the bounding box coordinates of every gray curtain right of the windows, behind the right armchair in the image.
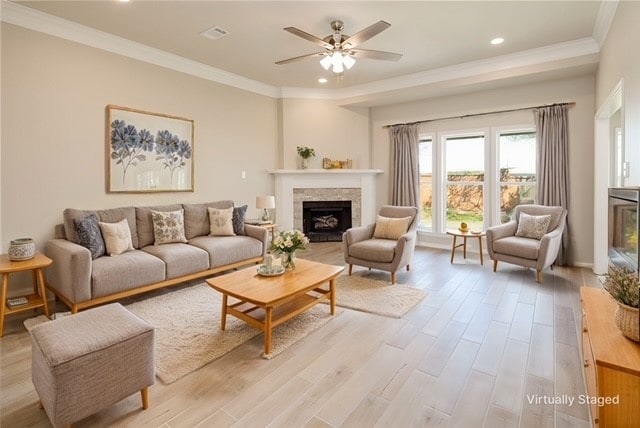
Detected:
[534,104,569,266]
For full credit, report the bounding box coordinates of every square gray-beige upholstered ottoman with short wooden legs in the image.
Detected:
[31,303,155,427]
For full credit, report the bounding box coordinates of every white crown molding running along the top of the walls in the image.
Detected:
[0,0,600,101]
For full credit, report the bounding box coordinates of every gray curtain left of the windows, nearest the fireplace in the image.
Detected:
[389,124,420,207]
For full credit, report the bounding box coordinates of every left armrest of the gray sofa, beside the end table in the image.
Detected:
[44,239,91,303]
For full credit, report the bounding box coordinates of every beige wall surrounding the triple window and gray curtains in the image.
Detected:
[371,76,594,265]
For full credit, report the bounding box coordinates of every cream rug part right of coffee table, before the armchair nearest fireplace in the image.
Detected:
[336,274,427,318]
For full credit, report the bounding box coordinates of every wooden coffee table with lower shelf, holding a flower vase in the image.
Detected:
[207,259,344,354]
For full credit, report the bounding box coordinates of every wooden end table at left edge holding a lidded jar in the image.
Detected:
[0,253,53,337]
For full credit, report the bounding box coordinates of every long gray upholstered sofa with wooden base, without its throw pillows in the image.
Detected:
[44,201,268,313]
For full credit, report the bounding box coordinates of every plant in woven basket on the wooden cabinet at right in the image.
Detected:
[604,265,640,342]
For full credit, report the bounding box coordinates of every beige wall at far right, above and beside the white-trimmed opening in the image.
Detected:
[596,1,640,186]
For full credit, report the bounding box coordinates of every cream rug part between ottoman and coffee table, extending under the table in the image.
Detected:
[24,283,340,384]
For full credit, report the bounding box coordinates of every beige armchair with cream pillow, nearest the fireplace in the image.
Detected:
[342,205,418,284]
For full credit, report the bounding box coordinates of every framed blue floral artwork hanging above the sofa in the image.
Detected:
[106,105,194,193]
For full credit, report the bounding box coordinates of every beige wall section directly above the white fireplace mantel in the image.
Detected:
[281,98,369,169]
